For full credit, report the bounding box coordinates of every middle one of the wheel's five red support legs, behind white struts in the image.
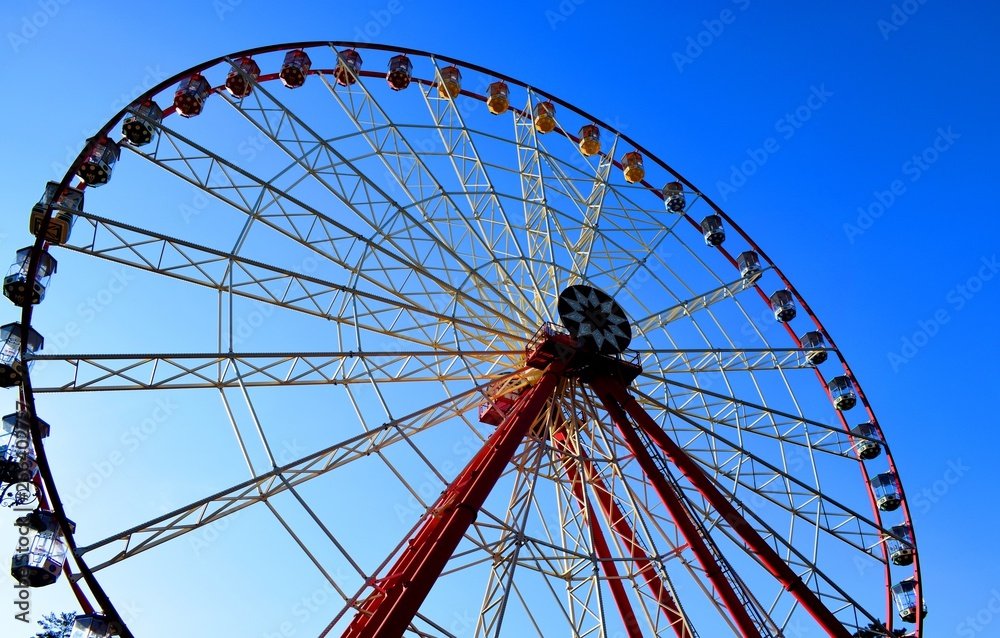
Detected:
[553,432,693,638]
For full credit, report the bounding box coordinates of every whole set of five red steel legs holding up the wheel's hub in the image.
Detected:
[343,344,851,638]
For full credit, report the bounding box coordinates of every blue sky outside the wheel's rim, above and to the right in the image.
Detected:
[0,0,1000,636]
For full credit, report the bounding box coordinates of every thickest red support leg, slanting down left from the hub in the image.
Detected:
[343,361,563,638]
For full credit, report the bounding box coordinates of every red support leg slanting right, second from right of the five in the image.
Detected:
[591,378,761,638]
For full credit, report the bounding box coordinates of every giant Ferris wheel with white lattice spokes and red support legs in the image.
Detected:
[0,42,926,638]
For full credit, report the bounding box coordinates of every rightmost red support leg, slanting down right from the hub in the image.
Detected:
[592,377,851,638]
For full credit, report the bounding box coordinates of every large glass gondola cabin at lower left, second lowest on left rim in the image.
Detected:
[10,510,75,587]
